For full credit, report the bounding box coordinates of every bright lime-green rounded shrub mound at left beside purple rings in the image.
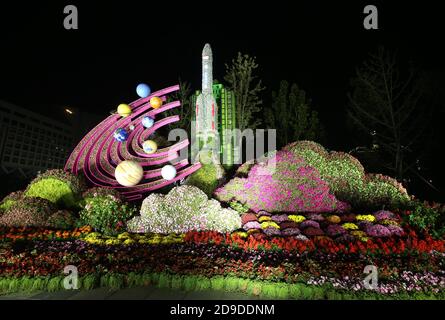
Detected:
[24,169,85,208]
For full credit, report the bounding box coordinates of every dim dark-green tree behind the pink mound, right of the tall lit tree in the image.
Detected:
[264,80,323,147]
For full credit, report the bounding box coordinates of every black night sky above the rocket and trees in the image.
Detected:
[0,0,445,198]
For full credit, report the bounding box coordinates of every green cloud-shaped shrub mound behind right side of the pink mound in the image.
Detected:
[283,141,410,209]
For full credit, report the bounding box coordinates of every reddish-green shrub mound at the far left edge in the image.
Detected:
[0,197,56,227]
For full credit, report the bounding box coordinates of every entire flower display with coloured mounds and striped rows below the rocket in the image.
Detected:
[0,142,445,299]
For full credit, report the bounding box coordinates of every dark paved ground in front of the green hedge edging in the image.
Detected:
[0,286,258,300]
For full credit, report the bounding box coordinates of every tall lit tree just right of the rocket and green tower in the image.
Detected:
[224,52,264,131]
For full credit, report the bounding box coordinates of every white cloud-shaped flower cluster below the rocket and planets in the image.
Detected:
[127,185,241,233]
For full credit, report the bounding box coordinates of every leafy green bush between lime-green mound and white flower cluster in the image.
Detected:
[80,197,136,235]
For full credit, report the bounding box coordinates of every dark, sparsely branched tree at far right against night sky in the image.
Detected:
[348,48,432,180]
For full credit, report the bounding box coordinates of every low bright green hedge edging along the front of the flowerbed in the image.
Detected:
[0,272,445,300]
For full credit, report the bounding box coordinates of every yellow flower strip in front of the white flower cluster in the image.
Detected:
[83,232,184,246]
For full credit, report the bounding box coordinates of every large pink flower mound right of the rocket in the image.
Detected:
[215,151,348,213]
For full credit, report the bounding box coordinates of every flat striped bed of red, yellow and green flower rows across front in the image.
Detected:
[0,227,445,299]
